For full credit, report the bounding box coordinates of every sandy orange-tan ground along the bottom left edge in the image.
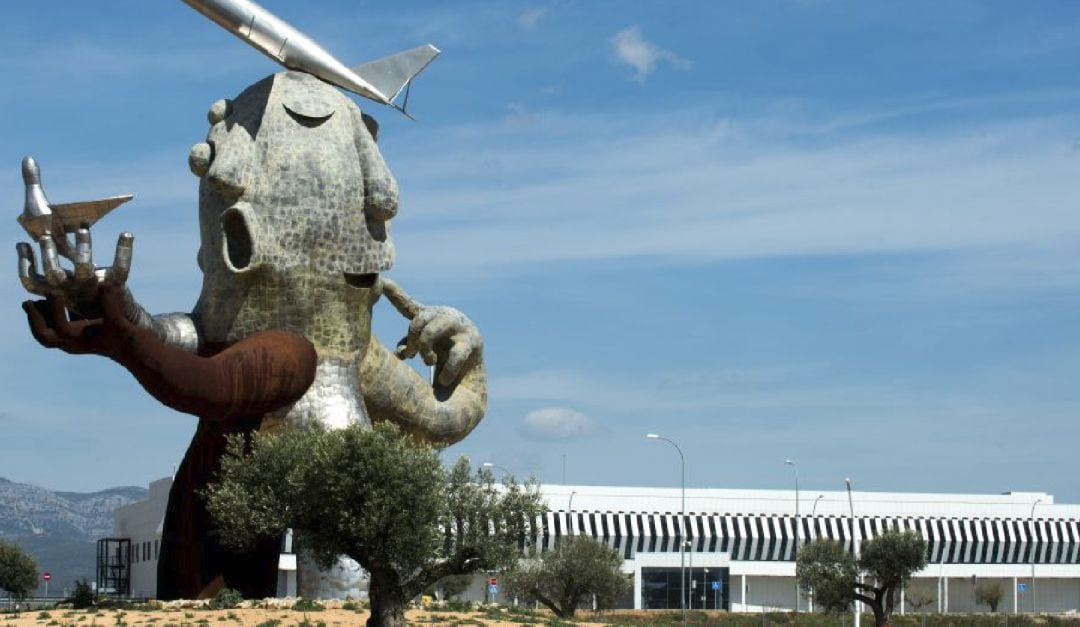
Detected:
[0,608,600,627]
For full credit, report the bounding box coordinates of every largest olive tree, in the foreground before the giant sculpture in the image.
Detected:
[206,423,542,627]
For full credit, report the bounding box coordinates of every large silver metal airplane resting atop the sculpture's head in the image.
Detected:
[184,0,438,115]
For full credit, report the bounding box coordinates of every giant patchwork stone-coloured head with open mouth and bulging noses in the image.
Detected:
[190,71,397,355]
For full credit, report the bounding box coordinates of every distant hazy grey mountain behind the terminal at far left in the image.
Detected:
[0,477,147,596]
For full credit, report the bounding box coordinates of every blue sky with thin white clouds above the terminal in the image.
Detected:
[0,0,1080,502]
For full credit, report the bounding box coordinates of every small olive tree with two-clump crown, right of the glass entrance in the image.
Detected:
[796,531,927,627]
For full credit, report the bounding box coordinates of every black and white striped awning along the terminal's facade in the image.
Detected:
[526,510,1080,563]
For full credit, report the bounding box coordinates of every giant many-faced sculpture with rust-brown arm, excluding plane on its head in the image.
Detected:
[17,3,487,599]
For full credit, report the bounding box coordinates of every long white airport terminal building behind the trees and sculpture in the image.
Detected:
[99,479,1080,613]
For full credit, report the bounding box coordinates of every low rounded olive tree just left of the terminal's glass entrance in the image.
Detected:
[507,535,632,618]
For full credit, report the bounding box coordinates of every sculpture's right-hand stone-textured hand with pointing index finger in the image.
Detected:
[380,277,484,386]
